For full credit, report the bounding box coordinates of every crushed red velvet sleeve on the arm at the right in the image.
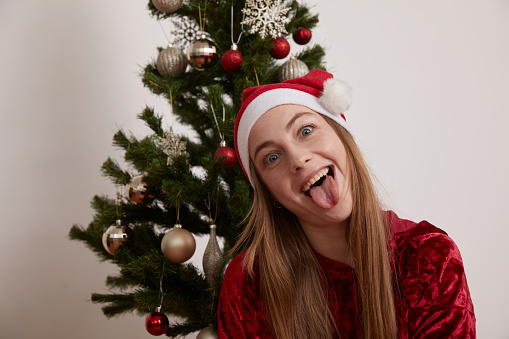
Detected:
[398,228,476,339]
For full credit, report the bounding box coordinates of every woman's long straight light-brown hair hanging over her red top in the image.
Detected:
[233,117,397,339]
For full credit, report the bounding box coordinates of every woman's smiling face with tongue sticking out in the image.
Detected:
[248,105,352,225]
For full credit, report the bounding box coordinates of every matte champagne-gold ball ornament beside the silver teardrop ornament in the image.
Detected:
[161,224,196,264]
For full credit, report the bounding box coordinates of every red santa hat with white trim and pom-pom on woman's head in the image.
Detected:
[234,69,352,183]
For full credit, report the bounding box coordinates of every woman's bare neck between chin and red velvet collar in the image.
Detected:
[301,219,354,266]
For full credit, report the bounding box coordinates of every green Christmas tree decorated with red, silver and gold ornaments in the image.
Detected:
[70,0,324,337]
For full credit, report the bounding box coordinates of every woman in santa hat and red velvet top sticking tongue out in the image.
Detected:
[218,70,475,339]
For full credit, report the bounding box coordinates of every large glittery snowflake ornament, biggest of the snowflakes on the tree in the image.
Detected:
[241,0,291,39]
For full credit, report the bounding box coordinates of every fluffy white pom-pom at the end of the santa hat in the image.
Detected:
[319,78,352,114]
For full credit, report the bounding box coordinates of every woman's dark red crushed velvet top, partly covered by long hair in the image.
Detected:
[218,212,476,339]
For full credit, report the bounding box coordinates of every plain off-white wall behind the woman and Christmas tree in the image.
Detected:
[0,0,509,339]
